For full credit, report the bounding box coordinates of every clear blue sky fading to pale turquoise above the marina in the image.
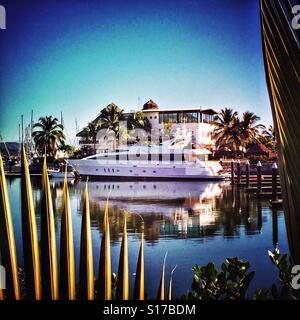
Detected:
[0,0,272,141]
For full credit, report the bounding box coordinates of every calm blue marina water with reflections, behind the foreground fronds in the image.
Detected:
[7,178,288,297]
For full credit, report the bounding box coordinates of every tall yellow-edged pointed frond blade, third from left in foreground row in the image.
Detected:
[41,157,59,300]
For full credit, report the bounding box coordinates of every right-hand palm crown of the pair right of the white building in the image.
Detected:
[239,111,265,148]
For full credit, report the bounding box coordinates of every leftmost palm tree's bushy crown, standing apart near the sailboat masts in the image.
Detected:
[32,116,65,156]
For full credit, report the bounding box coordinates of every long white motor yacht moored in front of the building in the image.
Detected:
[69,130,225,180]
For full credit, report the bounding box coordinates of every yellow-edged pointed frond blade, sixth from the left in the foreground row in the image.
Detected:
[99,199,112,300]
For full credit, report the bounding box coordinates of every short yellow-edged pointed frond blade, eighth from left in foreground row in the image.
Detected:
[133,233,145,300]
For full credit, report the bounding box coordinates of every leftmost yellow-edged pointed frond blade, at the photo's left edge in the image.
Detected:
[0,153,20,300]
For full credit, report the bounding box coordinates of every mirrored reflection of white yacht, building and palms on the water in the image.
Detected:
[26,180,270,244]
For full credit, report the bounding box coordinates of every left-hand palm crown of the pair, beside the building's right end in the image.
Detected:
[213,108,241,151]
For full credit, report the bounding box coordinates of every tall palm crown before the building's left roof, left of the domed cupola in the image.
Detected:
[99,103,123,138]
